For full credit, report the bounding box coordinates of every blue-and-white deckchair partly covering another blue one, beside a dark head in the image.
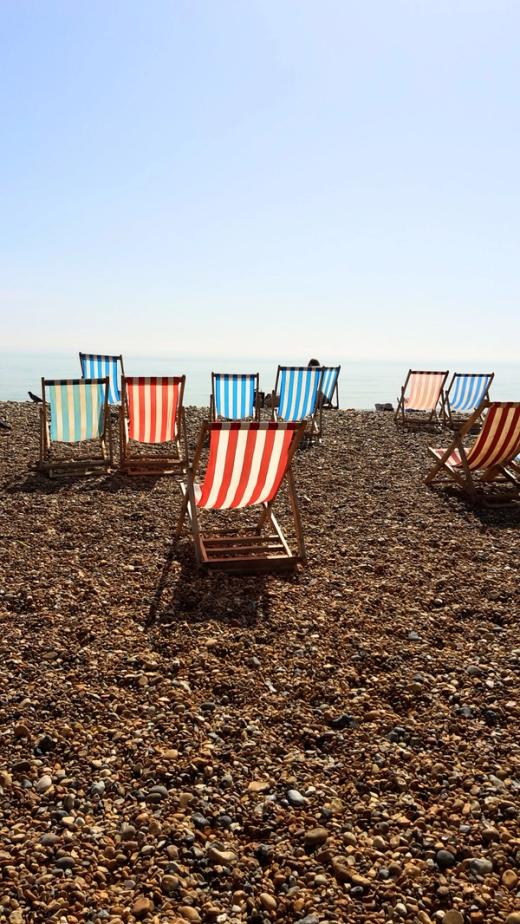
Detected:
[271,366,323,440]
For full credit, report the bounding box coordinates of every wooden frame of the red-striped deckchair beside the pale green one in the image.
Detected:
[119,375,188,475]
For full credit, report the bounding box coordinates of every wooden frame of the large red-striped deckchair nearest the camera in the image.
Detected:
[175,422,307,574]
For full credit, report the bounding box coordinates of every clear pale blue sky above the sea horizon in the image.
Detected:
[0,0,520,365]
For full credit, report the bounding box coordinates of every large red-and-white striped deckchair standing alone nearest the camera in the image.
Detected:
[177,421,305,572]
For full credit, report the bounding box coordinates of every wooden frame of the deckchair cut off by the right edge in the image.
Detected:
[424,400,520,502]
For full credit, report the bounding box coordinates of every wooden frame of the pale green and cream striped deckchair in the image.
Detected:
[37,376,114,478]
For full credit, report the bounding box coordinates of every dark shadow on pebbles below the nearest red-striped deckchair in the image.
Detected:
[147,540,274,628]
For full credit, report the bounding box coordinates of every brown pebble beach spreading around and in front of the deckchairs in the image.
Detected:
[0,402,520,924]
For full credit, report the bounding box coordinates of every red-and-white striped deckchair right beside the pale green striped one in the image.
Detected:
[120,375,188,475]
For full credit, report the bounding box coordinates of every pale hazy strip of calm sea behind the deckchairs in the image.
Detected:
[0,351,520,410]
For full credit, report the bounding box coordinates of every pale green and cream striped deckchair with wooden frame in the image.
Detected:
[38,377,112,478]
